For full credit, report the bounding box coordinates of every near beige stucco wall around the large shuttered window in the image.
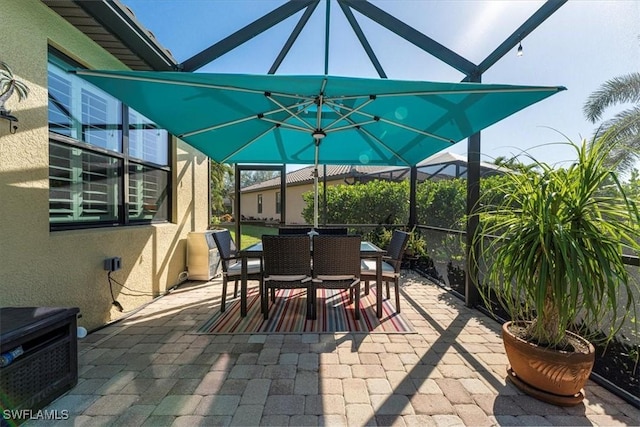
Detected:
[0,0,208,330]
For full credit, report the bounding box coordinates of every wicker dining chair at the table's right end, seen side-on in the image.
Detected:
[360,230,410,313]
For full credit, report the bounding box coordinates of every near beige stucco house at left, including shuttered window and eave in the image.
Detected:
[0,0,209,329]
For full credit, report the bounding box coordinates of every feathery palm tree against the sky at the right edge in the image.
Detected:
[583,73,640,172]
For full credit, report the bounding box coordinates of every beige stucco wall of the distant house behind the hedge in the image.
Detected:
[240,179,344,224]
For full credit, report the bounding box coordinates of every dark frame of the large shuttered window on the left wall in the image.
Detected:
[47,46,174,231]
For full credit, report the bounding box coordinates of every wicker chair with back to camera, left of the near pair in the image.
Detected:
[260,235,313,319]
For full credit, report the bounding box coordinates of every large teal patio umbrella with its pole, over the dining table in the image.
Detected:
[76,70,564,227]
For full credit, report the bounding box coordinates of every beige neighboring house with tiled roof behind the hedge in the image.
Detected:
[240,165,388,224]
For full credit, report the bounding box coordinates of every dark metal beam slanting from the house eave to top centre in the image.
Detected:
[181,0,319,71]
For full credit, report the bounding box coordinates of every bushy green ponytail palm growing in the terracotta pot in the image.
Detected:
[472,133,640,350]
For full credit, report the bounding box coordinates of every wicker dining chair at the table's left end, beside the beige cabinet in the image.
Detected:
[213,230,262,312]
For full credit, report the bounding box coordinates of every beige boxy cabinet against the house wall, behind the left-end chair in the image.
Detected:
[187,230,220,280]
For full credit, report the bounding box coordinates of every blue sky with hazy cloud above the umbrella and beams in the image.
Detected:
[121,0,640,171]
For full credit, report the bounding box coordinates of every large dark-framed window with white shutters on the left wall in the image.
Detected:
[48,49,171,230]
